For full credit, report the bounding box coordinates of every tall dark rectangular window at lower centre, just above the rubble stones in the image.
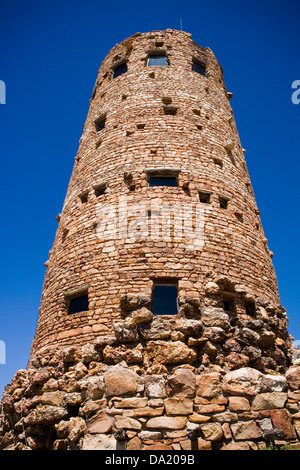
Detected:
[152,284,178,315]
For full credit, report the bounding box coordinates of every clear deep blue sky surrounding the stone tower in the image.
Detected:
[0,0,300,393]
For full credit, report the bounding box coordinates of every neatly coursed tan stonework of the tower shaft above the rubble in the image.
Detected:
[32,30,280,353]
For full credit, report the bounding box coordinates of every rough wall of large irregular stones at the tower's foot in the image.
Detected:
[0,338,300,451]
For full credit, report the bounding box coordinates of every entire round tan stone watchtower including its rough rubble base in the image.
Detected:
[2,30,298,450]
